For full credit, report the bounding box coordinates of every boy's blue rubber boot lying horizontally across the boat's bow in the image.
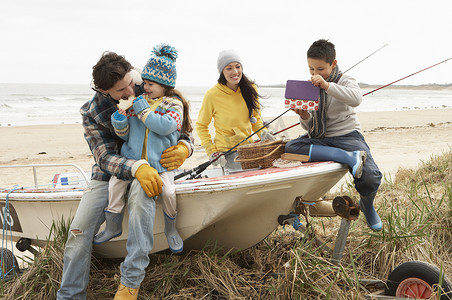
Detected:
[309,145,367,178]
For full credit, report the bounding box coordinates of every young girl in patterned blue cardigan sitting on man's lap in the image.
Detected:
[94,44,192,253]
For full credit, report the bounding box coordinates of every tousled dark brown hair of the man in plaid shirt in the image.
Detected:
[93,51,132,91]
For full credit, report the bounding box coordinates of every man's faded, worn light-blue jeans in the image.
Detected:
[57,179,155,299]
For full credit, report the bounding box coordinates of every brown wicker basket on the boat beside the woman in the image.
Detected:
[235,140,286,169]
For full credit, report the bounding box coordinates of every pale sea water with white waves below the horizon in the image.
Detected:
[0,83,452,126]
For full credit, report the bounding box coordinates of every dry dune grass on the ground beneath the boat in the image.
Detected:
[0,151,452,299]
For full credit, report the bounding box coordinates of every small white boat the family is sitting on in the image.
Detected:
[0,162,347,258]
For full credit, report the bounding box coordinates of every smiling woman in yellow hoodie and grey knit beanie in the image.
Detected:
[196,50,273,171]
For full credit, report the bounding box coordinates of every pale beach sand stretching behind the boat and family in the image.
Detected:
[0,109,452,187]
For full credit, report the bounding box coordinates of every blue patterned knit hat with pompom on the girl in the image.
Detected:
[141,44,177,87]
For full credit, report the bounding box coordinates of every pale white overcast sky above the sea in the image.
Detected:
[0,0,452,86]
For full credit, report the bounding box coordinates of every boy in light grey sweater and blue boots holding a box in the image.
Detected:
[286,39,383,231]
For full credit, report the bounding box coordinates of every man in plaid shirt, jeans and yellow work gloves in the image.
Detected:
[57,52,193,299]
